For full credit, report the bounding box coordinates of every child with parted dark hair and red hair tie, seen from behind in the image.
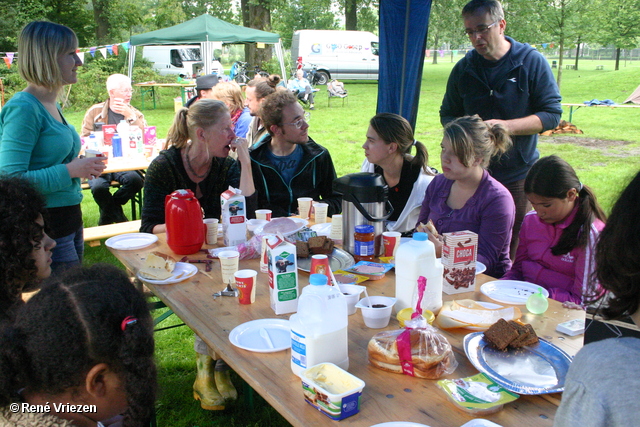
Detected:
[0,264,156,427]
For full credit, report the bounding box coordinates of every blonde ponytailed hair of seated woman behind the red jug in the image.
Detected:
[164,98,229,150]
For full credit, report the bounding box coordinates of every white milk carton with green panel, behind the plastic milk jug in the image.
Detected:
[267,233,300,314]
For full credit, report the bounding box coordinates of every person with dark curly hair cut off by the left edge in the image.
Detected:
[0,176,56,322]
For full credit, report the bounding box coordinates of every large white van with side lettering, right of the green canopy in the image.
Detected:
[291,30,378,84]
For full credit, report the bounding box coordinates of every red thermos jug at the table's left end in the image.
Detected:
[164,190,205,255]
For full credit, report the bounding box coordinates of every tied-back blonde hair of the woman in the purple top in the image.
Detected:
[444,114,511,168]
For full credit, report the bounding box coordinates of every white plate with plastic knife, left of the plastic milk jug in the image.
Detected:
[229,319,291,353]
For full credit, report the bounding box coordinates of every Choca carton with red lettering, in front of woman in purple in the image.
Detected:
[442,230,478,295]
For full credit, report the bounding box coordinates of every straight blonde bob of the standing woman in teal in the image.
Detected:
[18,21,78,91]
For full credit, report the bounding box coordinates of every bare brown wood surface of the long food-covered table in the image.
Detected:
[111,229,585,427]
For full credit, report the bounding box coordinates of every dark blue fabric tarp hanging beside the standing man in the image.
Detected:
[377,0,431,129]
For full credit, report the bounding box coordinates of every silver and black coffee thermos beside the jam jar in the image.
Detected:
[333,172,393,256]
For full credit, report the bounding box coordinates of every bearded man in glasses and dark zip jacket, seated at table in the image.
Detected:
[250,88,342,217]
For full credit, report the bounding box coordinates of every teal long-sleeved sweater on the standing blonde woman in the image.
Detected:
[0,92,82,208]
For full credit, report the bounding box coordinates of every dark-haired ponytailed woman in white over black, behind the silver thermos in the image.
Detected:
[360,113,436,233]
